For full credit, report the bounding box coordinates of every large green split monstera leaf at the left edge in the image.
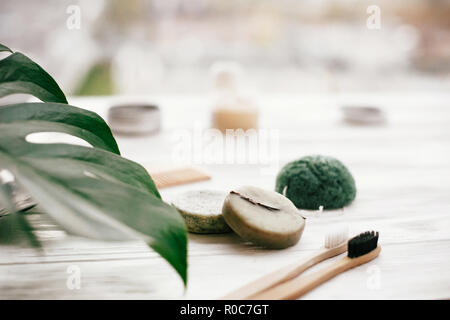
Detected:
[0,45,187,284]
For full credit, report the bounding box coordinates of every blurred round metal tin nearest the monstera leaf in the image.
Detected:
[108,104,161,135]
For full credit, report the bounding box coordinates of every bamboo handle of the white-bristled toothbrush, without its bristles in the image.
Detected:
[222,243,347,300]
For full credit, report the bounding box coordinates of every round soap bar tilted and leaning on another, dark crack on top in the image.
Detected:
[222,187,305,249]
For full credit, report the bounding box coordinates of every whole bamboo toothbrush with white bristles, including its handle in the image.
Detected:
[222,226,348,300]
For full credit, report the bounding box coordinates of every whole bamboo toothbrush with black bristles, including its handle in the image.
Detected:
[252,231,381,300]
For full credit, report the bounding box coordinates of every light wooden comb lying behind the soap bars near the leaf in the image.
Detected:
[148,167,211,189]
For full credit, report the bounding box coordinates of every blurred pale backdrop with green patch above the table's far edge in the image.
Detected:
[0,0,450,95]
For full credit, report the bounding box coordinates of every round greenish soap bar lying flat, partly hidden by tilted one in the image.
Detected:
[172,190,231,233]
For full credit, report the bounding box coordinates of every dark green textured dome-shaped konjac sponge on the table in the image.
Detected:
[275,155,356,210]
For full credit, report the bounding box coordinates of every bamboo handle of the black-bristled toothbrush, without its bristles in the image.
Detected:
[252,246,381,300]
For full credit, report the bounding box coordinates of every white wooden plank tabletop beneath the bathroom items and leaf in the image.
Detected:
[0,93,450,299]
